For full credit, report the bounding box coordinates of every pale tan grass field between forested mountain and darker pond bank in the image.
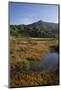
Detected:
[10,38,57,61]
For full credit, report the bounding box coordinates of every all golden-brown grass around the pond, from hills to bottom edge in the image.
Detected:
[10,38,59,87]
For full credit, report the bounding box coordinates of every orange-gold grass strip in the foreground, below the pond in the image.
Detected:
[10,71,59,87]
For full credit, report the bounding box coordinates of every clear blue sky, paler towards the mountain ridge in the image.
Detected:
[9,2,58,25]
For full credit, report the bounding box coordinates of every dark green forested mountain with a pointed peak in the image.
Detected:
[10,20,59,38]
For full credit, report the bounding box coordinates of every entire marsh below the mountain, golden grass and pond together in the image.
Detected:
[10,38,59,87]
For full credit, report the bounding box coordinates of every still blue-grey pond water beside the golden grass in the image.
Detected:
[30,52,59,71]
